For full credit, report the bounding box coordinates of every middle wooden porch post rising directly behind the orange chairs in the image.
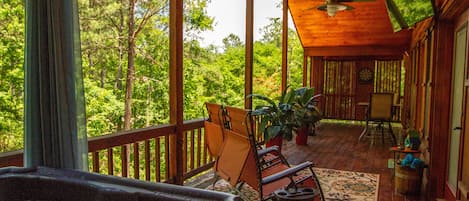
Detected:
[244,0,254,109]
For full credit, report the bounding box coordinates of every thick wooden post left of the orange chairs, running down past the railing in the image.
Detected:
[169,0,184,185]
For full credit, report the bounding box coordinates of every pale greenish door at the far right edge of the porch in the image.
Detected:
[447,23,467,198]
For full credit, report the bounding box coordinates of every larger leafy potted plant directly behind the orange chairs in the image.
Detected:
[247,87,295,152]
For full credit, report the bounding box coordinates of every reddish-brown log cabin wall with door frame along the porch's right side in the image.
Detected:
[404,0,469,200]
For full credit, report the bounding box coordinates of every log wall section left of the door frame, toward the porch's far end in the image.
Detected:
[403,16,432,198]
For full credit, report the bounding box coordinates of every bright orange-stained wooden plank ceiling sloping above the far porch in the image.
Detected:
[288,0,411,56]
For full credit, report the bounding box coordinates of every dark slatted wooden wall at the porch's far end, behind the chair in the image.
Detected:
[310,57,402,121]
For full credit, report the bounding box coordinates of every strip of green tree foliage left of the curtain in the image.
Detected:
[0,0,24,152]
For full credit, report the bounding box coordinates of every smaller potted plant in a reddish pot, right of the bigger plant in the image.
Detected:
[291,87,322,145]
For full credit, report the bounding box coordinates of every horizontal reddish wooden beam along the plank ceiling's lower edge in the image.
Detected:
[304,46,406,57]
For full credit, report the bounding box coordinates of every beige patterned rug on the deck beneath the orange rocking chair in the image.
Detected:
[207,168,379,201]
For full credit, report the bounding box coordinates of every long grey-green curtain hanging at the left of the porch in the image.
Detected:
[24,0,88,170]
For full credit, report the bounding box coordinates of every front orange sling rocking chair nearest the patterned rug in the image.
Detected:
[215,107,323,200]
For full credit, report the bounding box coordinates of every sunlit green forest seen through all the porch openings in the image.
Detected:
[0,0,303,152]
